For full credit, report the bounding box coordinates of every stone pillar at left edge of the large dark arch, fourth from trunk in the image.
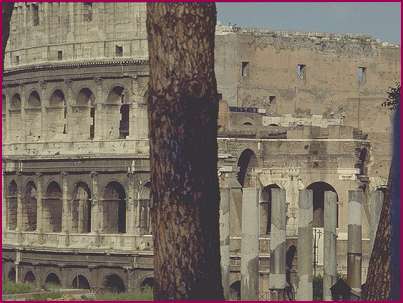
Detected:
[296,189,313,301]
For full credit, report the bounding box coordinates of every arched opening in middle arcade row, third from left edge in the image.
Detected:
[43,181,63,232]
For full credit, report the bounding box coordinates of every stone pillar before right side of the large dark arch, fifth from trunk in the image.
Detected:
[323,191,337,301]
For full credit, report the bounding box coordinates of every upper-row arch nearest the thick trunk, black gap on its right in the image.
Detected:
[105,86,130,139]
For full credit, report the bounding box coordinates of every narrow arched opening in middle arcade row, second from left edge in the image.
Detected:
[22,182,37,231]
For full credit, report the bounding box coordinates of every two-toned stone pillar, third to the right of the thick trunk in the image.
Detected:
[269,188,287,300]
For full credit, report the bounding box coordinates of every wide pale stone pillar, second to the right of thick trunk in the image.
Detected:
[241,187,260,300]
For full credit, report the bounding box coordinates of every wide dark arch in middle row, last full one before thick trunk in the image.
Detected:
[103,182,126,234]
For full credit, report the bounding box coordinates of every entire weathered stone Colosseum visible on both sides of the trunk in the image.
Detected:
[2,2,400,302]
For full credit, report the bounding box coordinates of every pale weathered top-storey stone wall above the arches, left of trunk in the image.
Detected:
[5,2,148,68]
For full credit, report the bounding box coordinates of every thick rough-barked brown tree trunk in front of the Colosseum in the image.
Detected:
[147,3,223,300]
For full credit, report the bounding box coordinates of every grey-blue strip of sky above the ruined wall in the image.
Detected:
[216,2,401,44]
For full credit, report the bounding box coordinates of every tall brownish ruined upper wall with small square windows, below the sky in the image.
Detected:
[216,27,400,185]
